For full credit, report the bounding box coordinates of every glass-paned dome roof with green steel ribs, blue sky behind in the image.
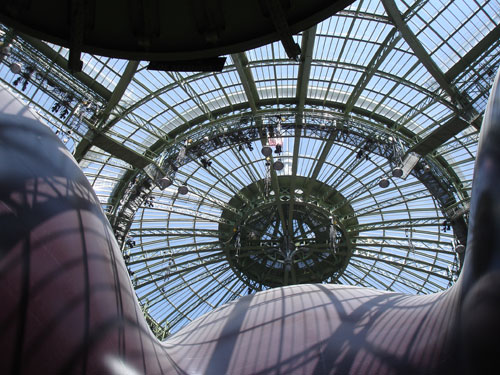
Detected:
[0,0,500,337]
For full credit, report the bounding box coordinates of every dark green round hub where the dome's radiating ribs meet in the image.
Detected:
[219,176,356,288]
